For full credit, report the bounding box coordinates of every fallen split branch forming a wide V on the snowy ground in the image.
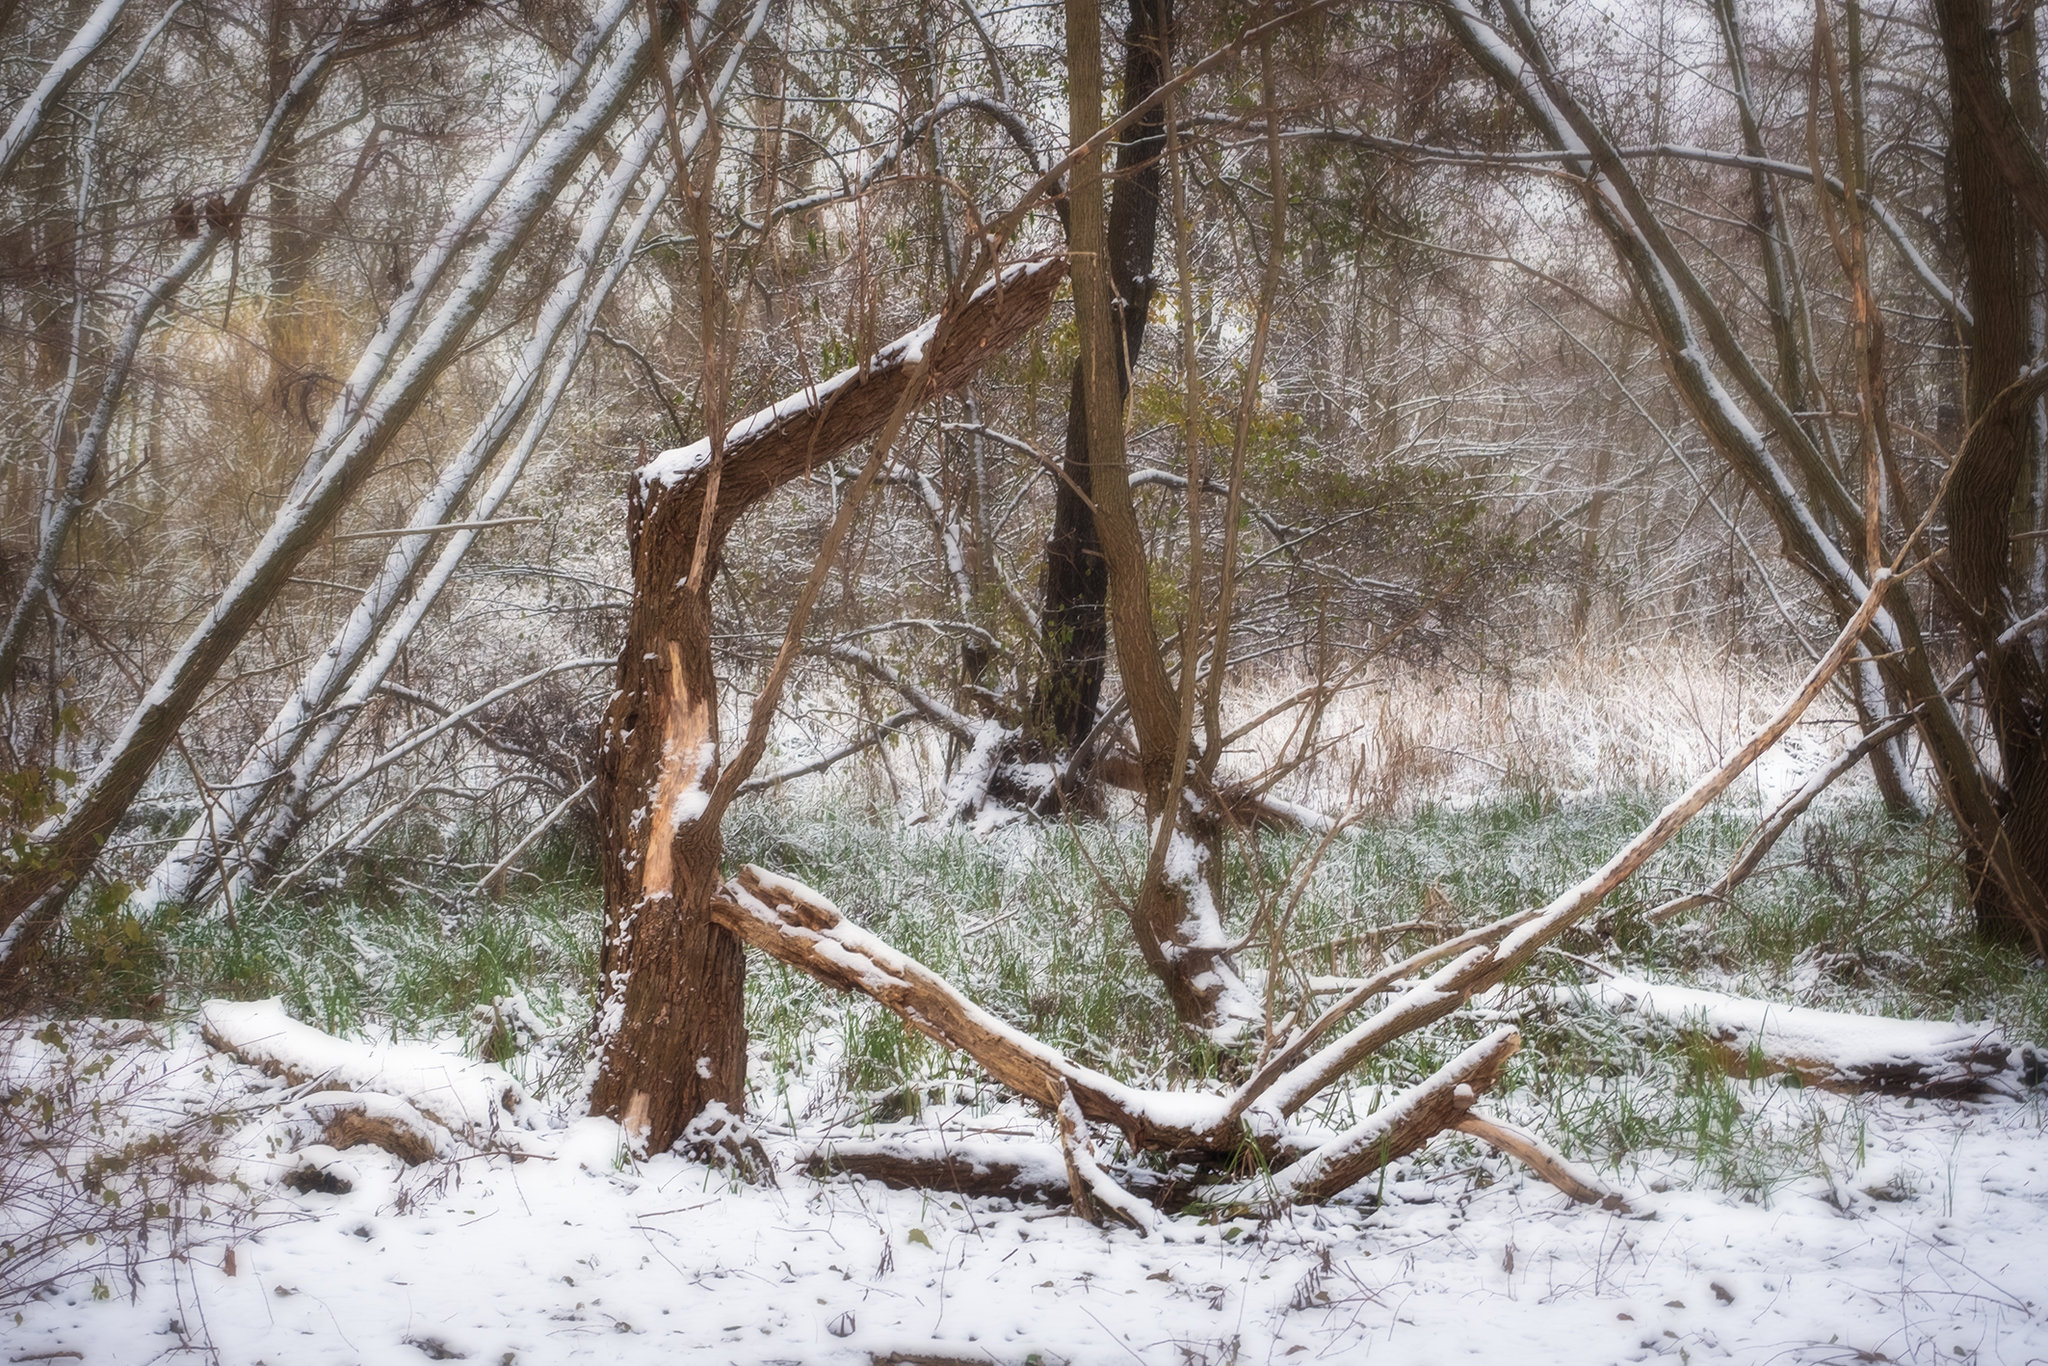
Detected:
[709,571,1896,1208]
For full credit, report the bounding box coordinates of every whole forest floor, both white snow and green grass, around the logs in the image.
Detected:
[0,774,2048,1366]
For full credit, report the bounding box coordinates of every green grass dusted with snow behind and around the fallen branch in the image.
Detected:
[32,778,2048,1198]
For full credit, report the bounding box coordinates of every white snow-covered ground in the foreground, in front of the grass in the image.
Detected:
[0,1024,2048,1366]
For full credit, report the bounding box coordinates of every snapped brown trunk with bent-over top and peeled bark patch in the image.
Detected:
[590,262,1063,1151]
